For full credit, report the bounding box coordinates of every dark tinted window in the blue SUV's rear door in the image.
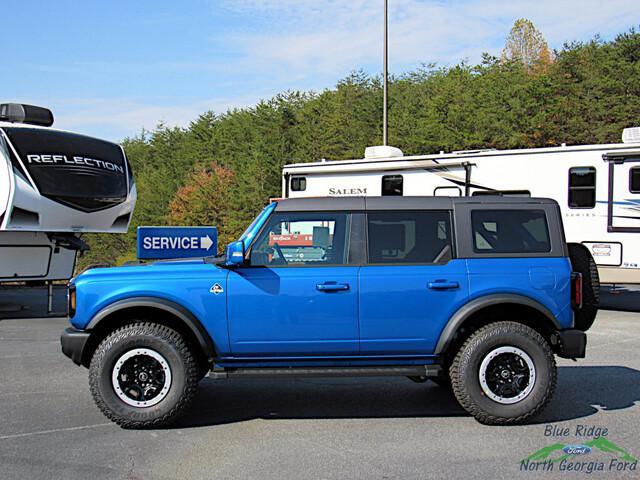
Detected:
[367,210,452,265]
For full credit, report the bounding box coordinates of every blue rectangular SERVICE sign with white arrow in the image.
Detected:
[138,227,218,259]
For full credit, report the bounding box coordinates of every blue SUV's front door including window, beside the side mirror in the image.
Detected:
[227,212,359,357]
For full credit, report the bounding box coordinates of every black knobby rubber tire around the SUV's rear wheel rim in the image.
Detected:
[449,322,557,425]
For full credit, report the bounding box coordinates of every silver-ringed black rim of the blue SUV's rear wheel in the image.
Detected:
[479,346,536,405]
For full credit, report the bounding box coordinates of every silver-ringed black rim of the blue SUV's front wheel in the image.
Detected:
[111,348,172,408]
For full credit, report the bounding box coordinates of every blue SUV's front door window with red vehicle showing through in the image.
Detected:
[251,212,351,266]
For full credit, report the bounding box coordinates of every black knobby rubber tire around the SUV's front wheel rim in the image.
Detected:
[89,322,199,429]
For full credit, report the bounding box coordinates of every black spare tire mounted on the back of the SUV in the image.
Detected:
[568,243,600,332]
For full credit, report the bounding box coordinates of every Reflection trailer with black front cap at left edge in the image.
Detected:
[0,104,136,284]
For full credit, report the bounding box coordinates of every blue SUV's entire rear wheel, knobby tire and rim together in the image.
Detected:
[449,322,557,425]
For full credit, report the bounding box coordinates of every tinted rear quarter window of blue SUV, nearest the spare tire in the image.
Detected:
[471,210,551,253]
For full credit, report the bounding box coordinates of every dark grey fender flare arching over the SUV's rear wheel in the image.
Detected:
[434,293,562,355]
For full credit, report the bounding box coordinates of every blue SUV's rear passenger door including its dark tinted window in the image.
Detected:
[360,210,469,355]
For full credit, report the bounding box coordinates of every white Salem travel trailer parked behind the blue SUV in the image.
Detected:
[282,128,640,284]
